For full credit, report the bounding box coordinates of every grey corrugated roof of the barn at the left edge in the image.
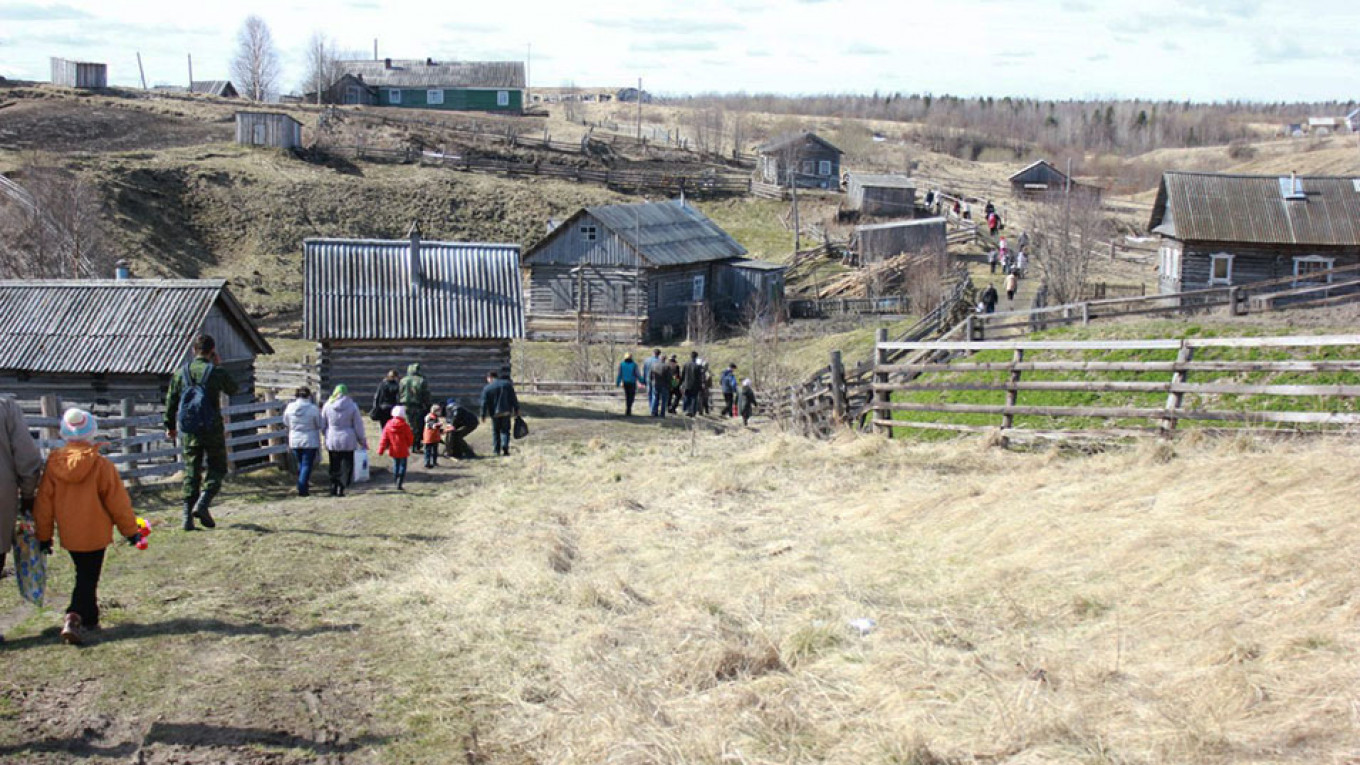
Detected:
[0,279,273,374]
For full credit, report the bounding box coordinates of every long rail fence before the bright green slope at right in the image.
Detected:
[872,335,1360,437]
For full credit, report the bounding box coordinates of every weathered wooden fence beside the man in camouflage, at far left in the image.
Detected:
[26,395,288,485]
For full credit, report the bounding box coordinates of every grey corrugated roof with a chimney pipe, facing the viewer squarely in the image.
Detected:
[302,240,524,340]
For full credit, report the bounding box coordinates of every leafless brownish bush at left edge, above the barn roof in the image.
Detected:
[0,163,116,279]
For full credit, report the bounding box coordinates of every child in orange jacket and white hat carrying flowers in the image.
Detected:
[33,408,141,644]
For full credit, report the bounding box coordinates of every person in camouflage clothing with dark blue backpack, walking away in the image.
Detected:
[165,335,241,531]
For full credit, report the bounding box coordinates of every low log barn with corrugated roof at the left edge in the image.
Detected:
[0,279,273,411]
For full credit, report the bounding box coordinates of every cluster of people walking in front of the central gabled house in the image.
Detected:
[615,348,758,425]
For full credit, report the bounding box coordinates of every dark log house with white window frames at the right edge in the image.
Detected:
[1148,172,1360,294]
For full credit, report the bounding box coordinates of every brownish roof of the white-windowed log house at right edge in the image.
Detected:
[1148,172,1360,246]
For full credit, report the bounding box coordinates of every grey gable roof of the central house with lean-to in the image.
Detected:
[525,200,747,267]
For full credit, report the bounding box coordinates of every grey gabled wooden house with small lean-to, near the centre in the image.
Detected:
[524,201,783,342]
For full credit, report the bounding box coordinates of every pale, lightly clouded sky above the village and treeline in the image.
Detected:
[0,0,1360,101]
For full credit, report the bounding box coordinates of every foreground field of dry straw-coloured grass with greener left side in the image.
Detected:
[0,399,1360,765]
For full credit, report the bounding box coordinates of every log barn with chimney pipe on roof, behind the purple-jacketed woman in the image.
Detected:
[302,227,524,403]
